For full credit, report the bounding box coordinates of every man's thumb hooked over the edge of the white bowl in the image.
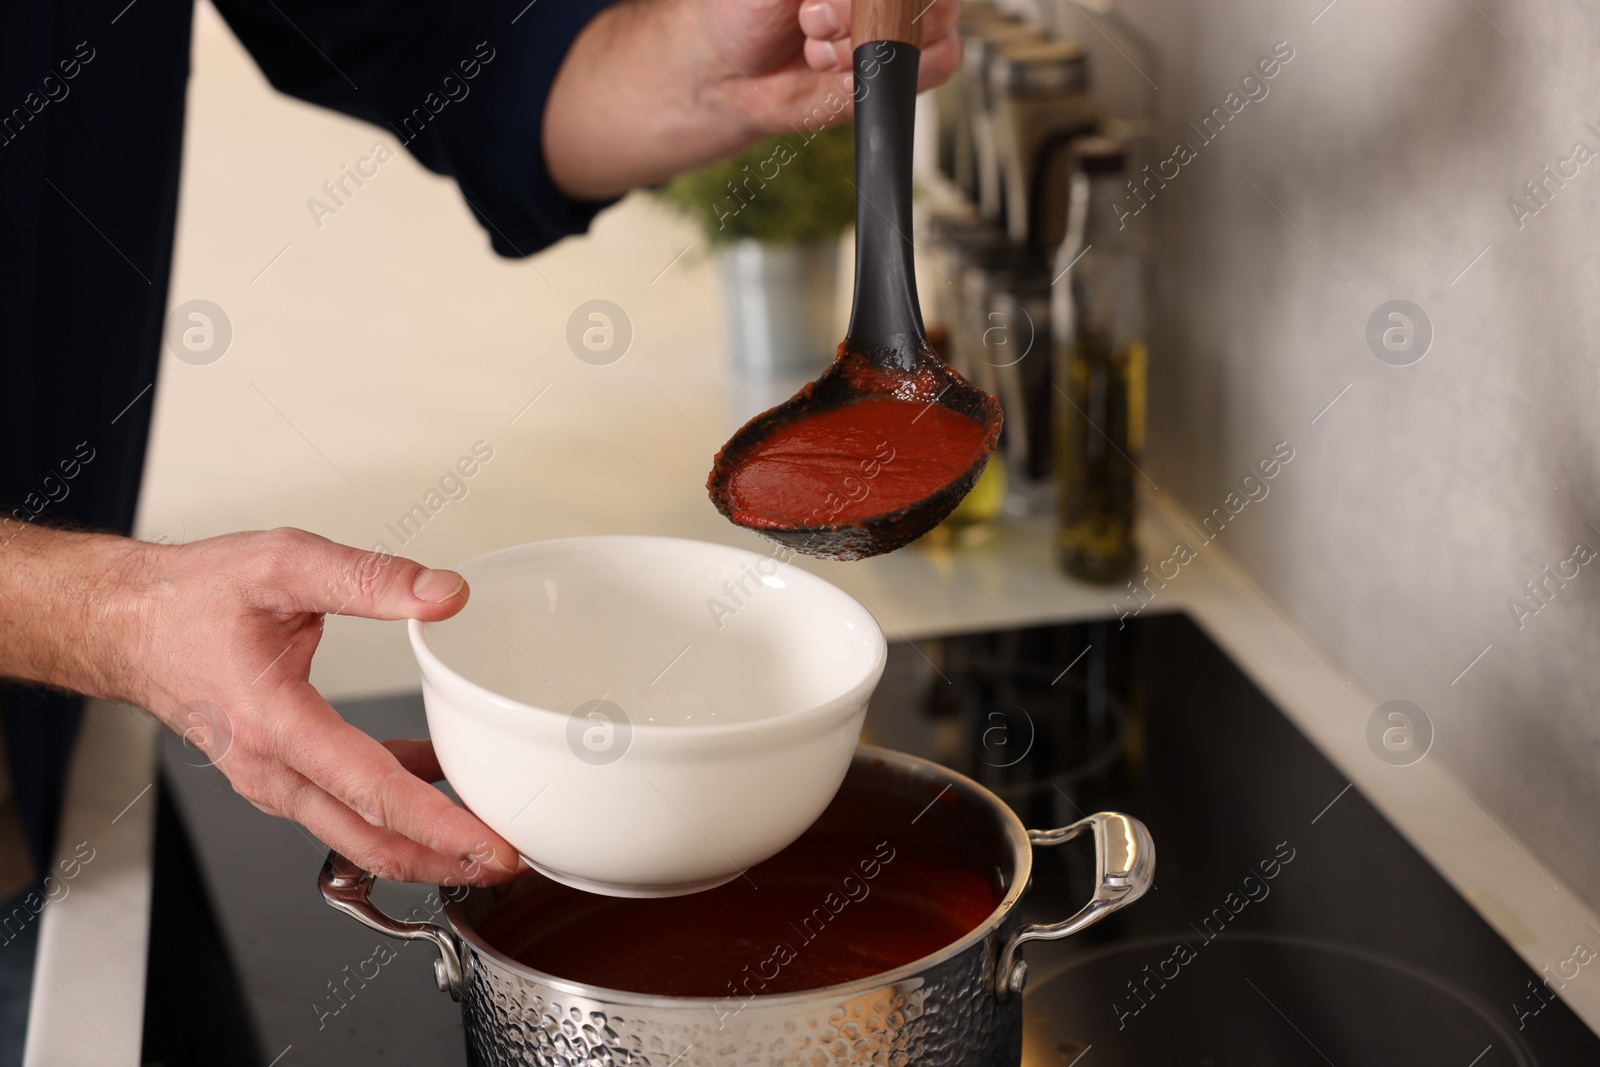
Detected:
[246,528,469,621]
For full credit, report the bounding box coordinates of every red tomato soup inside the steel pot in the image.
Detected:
[480,838,1000,998]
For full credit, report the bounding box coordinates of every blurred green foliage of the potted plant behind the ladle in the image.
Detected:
[656,125,856,245]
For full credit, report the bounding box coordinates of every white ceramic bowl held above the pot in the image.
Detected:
[410,537,886,896]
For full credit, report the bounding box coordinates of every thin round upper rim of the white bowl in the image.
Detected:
[406,534,888,747]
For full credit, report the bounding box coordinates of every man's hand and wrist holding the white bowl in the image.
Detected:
[0,528,518,885]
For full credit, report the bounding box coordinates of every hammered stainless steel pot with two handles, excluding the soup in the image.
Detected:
[320,745,1155,1067]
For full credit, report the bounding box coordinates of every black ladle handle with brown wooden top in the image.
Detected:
[848,0,928,371]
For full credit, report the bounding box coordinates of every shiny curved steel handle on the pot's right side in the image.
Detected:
[995,811,1155,1003]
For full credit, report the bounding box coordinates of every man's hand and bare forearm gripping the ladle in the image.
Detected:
[544,0,962,200]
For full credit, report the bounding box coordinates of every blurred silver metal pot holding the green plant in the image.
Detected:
[718,238,840,379]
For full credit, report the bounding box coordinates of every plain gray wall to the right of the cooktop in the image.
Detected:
[1046,0,1600,905]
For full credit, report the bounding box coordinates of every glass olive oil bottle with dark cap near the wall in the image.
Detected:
[1051,138,1149,582]
